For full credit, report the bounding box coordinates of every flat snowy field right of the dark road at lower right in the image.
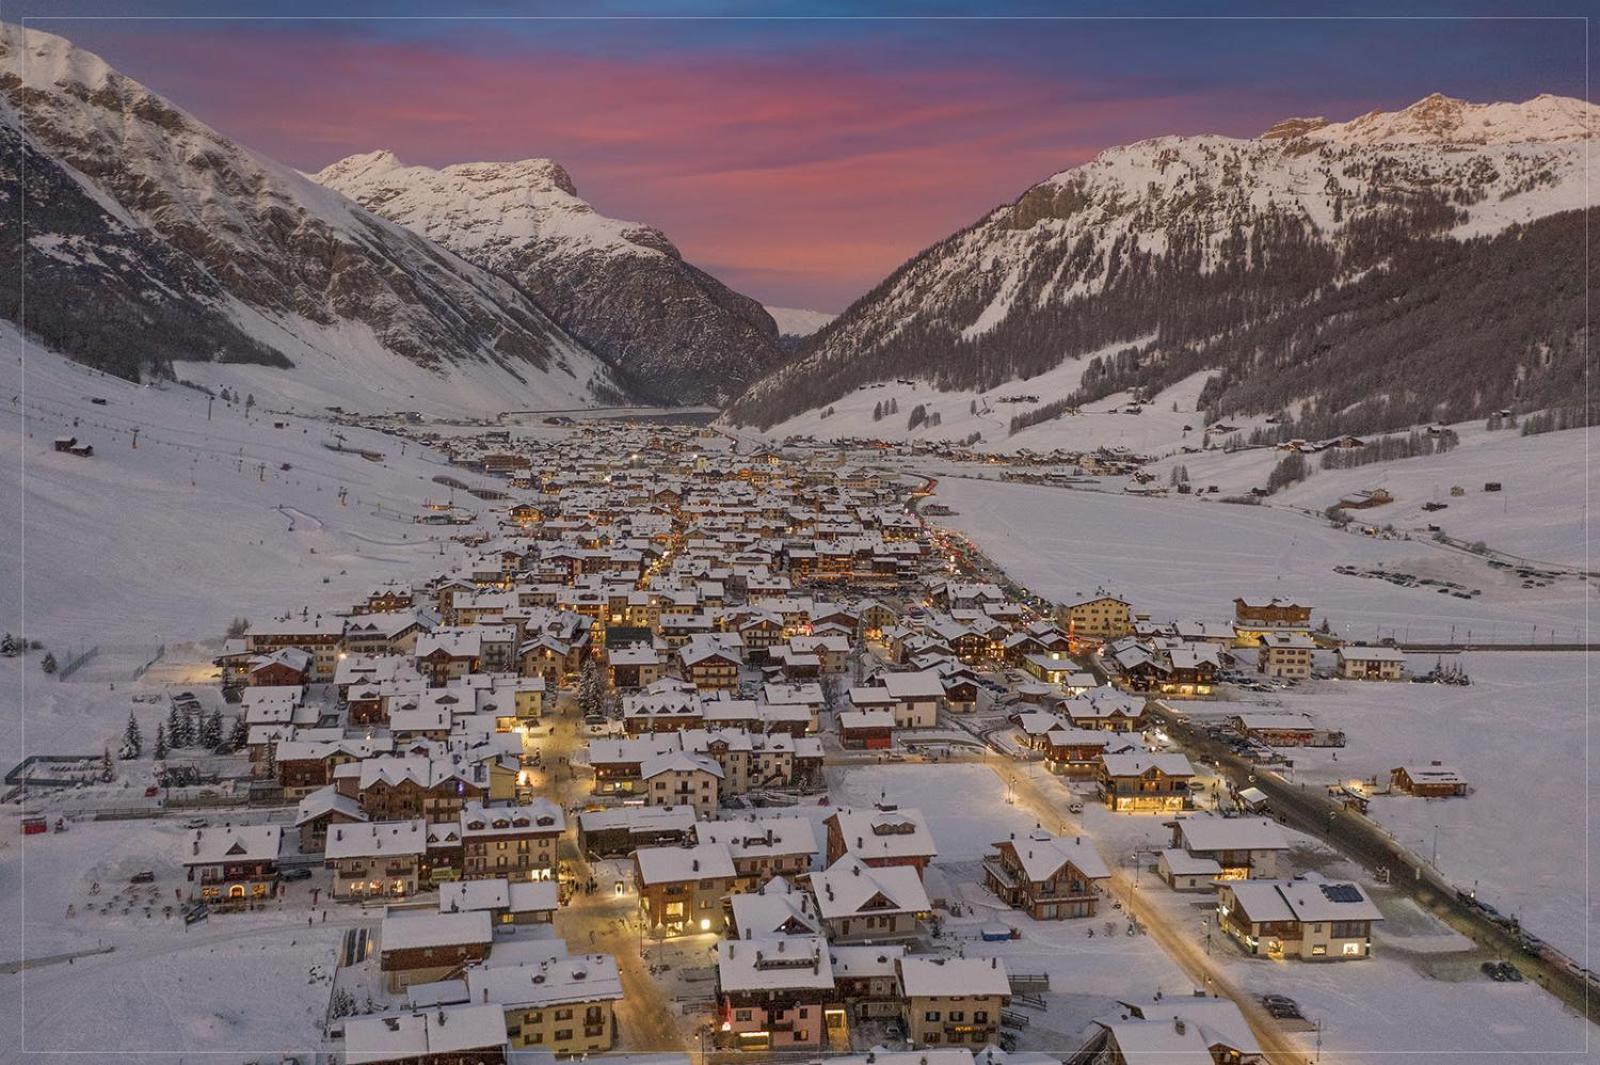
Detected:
[1181,652,1600,958]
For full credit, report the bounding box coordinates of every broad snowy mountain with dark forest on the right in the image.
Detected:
[730,96,1600,427]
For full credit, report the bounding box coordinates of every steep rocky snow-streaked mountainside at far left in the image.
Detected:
[0,24,622,411]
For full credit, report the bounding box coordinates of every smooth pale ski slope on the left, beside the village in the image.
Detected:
[0,323,504,657]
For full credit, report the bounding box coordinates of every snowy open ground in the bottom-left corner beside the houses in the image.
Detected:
[0,812,360,1062]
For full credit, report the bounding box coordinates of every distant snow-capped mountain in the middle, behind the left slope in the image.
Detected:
[314,152,782,403]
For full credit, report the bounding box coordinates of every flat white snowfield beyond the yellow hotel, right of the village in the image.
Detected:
[934,477,1594,641]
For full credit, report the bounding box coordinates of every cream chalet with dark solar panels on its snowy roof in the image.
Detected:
[1216,876,1384,961]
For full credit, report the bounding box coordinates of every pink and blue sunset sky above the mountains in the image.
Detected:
[18,0,1587,310]
